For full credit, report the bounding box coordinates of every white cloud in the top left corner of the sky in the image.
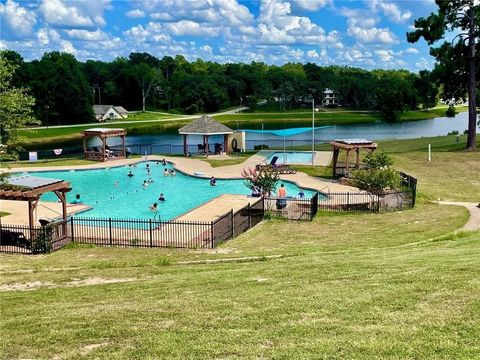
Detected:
[0,0,37,39]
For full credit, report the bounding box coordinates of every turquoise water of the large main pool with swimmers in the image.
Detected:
[29,162,313,220]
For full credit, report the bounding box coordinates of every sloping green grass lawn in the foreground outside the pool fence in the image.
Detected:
[0,137,480,359]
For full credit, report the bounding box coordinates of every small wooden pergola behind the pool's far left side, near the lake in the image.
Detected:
[82,128,127,161]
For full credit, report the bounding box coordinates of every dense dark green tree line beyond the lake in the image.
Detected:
[2,50,439,125]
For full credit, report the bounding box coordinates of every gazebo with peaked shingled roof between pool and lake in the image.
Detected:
[178,115,233,156]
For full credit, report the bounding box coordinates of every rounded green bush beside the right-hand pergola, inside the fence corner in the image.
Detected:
[351,167,402,194]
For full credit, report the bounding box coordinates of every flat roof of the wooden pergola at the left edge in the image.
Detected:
[0,175,71,200]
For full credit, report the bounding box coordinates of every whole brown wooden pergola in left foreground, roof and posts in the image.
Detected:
[0,175,72,229]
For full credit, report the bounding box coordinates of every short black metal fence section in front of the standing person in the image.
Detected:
[265,193,319,221]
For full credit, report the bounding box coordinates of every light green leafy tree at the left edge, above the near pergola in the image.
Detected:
[0,52,39,183]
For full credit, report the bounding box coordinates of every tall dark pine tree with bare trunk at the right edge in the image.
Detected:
[407,0,480,149]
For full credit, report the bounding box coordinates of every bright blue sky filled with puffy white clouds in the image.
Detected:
[0,0,435,72]
